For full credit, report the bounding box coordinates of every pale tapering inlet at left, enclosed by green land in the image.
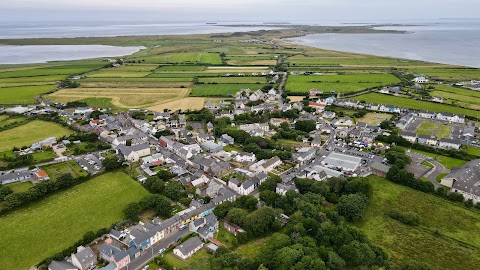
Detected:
[0,45,144,64]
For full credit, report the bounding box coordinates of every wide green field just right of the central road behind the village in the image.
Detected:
[285,74,400,93]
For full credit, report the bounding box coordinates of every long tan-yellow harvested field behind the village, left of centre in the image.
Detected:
[47,88,190,108]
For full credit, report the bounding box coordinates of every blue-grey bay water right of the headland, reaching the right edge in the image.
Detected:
[287,20,480,68]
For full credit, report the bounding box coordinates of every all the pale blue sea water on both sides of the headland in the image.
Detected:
[0,19,480,68]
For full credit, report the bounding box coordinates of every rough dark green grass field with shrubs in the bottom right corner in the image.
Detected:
[357,177,480,270]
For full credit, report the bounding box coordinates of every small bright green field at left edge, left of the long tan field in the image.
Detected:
[0,85,55,104]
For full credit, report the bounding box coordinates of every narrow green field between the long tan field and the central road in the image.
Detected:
[192,84,266,97]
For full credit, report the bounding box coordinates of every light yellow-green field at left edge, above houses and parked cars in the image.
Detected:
[0,120,73,152]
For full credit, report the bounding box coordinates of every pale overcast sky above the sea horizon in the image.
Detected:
[0,0,480,23]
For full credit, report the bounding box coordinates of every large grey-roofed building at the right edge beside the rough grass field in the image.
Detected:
[440,159,480,203]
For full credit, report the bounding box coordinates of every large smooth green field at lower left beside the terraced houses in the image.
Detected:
[0,172,148,269]
